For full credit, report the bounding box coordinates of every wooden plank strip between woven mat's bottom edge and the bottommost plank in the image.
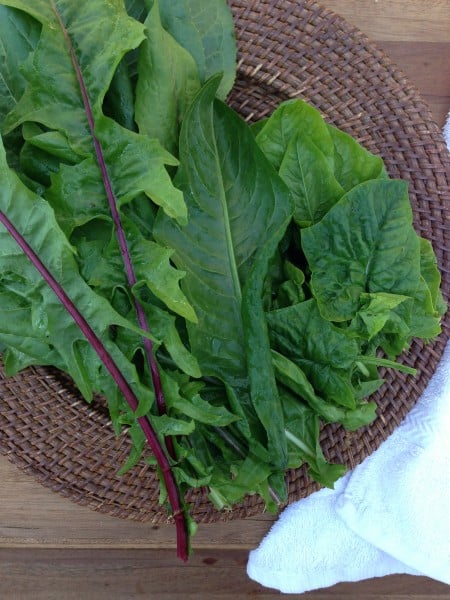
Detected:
[0,456,275,552]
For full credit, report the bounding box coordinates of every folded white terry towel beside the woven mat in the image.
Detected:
[247,114,450,593]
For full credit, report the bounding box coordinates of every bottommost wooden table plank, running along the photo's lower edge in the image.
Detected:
[0,548,450,600]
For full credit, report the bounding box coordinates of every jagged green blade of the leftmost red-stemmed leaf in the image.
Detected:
[0,135,153,408]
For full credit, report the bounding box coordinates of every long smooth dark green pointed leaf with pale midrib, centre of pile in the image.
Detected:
[155,78,292,468]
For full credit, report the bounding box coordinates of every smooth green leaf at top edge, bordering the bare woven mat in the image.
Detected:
[160,0,236,99]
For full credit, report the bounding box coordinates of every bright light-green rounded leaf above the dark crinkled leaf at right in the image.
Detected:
[256,100,385,227]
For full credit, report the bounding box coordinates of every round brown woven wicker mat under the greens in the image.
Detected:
[0,0,450,522]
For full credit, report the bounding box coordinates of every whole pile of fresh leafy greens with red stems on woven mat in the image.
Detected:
[0,0,445,558]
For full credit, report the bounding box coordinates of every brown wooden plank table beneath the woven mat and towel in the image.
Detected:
[0,0,450,600]
